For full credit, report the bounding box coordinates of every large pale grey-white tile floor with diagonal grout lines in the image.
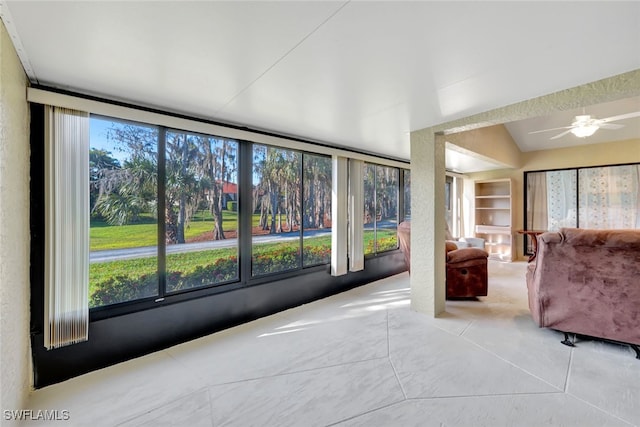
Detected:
[21,262,640,427]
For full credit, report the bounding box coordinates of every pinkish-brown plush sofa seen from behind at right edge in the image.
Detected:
[527,228,640,359]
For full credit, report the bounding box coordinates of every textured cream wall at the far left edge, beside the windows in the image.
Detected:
[0,22,31,410]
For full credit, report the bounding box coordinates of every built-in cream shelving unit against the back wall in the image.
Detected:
[475,179,513,261]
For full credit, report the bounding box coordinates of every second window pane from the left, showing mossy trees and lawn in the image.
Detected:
[164,131,238,292]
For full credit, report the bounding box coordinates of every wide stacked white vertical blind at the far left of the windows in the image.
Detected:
[44,106,89,350]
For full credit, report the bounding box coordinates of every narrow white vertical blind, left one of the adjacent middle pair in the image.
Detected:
[331,156,348,276]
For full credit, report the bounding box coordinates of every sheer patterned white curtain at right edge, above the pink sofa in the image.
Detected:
[579,165,640,229]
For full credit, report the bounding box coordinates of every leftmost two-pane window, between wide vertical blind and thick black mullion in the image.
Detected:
[89,116,239,308]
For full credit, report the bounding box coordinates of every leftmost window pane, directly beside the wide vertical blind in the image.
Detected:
[89,117,158,307]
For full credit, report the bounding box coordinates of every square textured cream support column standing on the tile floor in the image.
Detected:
[410,129,445,317]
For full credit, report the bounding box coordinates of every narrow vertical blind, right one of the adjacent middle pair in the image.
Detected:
[349,159,364,271]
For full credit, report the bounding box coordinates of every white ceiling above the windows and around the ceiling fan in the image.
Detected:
[0,0,640,169]
